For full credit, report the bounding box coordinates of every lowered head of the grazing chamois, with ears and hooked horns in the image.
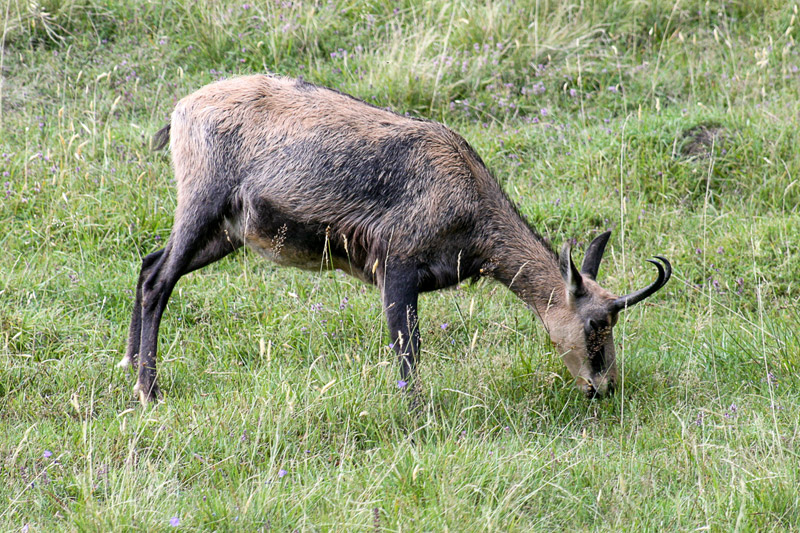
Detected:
[549,231,672,398]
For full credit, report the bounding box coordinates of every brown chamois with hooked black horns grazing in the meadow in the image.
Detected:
[120,75,671,403]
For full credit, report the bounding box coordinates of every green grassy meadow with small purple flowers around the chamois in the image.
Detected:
[0,0,800,531]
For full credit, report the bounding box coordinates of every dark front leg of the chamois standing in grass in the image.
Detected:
[380,265,420,390]
